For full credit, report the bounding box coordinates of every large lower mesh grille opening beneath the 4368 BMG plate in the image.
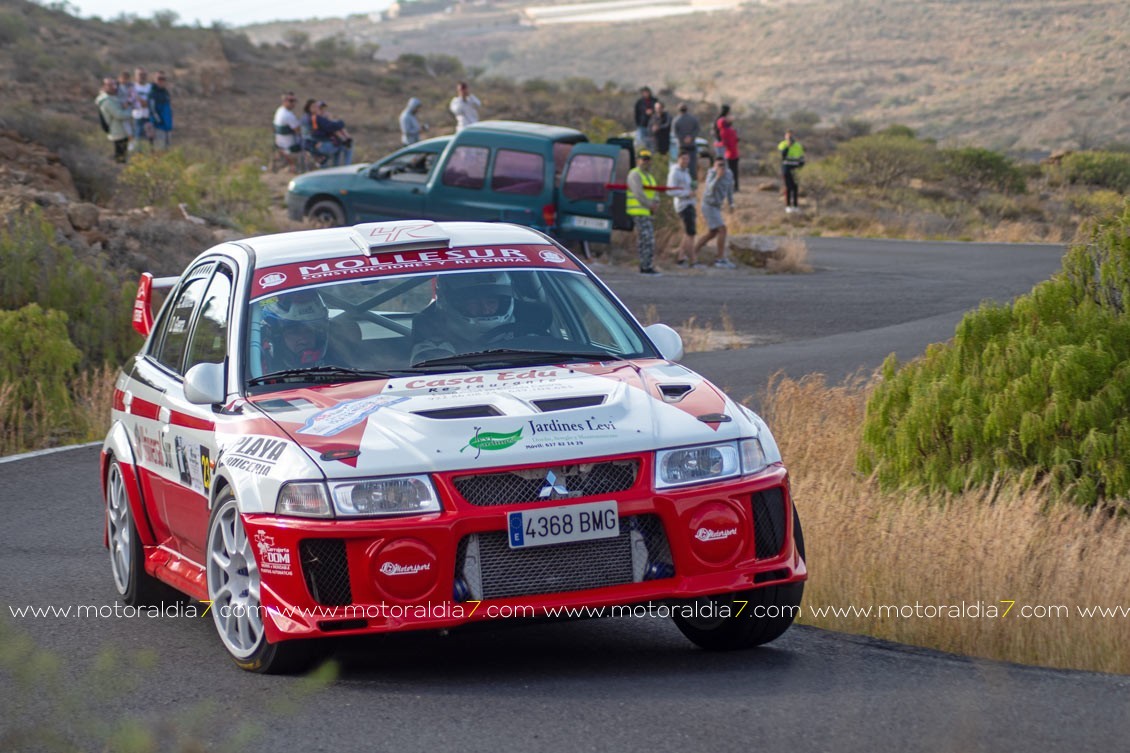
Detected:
[455,514,675,600]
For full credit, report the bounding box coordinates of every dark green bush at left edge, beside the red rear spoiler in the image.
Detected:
[0,210,137,369]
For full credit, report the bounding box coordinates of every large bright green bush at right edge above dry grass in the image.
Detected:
[859,201,1130,504]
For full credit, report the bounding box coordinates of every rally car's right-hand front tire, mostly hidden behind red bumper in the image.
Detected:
[671,507,805,651]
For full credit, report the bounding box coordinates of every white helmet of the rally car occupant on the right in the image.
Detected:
[435,271,514,340]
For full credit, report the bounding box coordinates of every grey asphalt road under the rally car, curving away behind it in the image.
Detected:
[0,240,1130,753]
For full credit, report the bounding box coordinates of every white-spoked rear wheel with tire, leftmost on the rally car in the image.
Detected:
[106,460,162,606]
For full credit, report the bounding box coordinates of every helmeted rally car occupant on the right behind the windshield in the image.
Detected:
[411,271,550,364]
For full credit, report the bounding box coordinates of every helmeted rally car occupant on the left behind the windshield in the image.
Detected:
[262,291,341,373]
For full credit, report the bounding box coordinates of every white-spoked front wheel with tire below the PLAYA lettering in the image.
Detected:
[206,488,315,674]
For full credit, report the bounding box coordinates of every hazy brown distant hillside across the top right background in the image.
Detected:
[246,0,1130,153]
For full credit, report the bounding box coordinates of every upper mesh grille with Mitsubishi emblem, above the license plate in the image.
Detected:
[453,460,640,507]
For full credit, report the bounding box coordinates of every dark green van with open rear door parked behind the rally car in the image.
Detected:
[287,120,633,243]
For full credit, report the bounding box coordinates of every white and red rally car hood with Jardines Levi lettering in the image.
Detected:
[252,361,762,477]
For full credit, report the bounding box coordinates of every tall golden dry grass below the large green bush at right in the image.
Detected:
[763,375,1130,673]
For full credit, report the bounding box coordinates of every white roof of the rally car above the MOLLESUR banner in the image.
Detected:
[237,219,553,269]
